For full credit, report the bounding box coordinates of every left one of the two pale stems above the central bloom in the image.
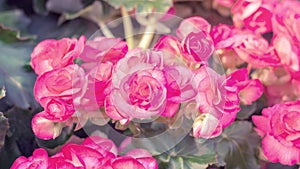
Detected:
[121,6,134,49]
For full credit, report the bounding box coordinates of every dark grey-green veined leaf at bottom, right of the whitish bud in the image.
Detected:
[216,121,260,169]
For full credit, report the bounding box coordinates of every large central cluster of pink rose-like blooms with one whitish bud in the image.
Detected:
[32,14,247,139]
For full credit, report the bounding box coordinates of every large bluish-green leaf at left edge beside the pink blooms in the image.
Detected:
[0,42,37,109]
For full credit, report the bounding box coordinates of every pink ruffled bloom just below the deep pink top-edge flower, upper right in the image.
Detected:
[234,34,280,68]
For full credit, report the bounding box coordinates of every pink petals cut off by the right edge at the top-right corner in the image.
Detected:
[272,0,300,74]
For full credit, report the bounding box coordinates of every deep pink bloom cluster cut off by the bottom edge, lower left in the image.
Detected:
[11,136,158,169]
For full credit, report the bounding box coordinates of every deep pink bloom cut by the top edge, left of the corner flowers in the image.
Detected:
[231,0,276,34]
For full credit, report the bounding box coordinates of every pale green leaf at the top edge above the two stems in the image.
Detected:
[106,0,173,13]
